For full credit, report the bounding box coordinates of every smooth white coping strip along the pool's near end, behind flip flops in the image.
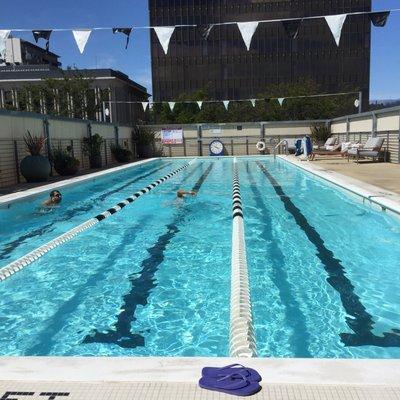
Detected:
[0,357,400,386]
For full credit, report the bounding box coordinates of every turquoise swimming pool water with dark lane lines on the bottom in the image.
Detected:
[0,157,400,358]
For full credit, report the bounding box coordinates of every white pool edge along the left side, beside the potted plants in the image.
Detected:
[0,157,158,207]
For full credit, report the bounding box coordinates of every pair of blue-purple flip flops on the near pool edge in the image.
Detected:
[199,364,262,396]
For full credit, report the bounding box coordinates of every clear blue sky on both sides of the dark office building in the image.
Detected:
[0,0,400,99]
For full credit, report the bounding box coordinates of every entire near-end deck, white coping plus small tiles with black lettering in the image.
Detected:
[0,357,400,400]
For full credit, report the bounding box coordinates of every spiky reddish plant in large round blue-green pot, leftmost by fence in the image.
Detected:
[20,131,51,182]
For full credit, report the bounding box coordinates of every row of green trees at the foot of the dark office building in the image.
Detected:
[150,80,358,124]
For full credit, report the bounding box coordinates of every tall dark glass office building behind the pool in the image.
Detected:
[149,0,371,105]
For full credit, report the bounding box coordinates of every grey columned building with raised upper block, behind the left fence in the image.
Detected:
[0,38,149,126]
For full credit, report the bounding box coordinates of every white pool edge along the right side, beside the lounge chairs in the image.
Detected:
[277,155,400,218]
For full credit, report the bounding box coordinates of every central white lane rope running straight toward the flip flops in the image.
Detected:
[230,158,257,358]
